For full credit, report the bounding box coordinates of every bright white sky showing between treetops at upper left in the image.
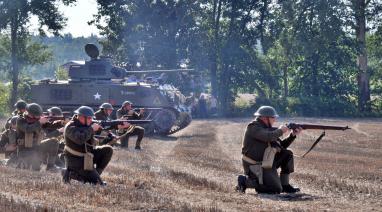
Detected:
[31,0,99,37]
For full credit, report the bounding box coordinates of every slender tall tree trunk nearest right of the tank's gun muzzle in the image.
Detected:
[210,0,221,97]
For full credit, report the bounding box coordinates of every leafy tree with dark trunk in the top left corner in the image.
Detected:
[0,0,75,108]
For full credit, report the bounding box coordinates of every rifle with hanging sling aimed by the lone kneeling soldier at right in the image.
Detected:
[276,123,351,157]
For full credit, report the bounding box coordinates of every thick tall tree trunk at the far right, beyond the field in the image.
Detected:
[353,0,371,112]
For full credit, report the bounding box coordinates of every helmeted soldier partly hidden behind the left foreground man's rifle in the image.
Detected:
[94,103,130,144]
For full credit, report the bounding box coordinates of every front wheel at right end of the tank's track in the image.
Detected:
[153,109,176,134]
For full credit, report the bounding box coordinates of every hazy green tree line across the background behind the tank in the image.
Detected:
[0,0,382,116]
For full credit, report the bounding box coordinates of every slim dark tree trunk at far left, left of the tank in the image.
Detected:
[9,15,19,109]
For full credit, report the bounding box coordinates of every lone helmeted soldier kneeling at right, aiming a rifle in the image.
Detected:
[236,106,302,194]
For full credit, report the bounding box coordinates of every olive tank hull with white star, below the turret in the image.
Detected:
[31,81,191,135]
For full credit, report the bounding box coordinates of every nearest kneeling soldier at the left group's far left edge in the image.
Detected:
[9,103,58,171]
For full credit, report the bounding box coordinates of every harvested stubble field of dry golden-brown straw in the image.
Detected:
[0,118,382,211]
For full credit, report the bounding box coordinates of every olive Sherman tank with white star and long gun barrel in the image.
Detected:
[31,44,191,135]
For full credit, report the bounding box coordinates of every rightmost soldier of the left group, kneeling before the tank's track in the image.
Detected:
[117,101,145,150]
